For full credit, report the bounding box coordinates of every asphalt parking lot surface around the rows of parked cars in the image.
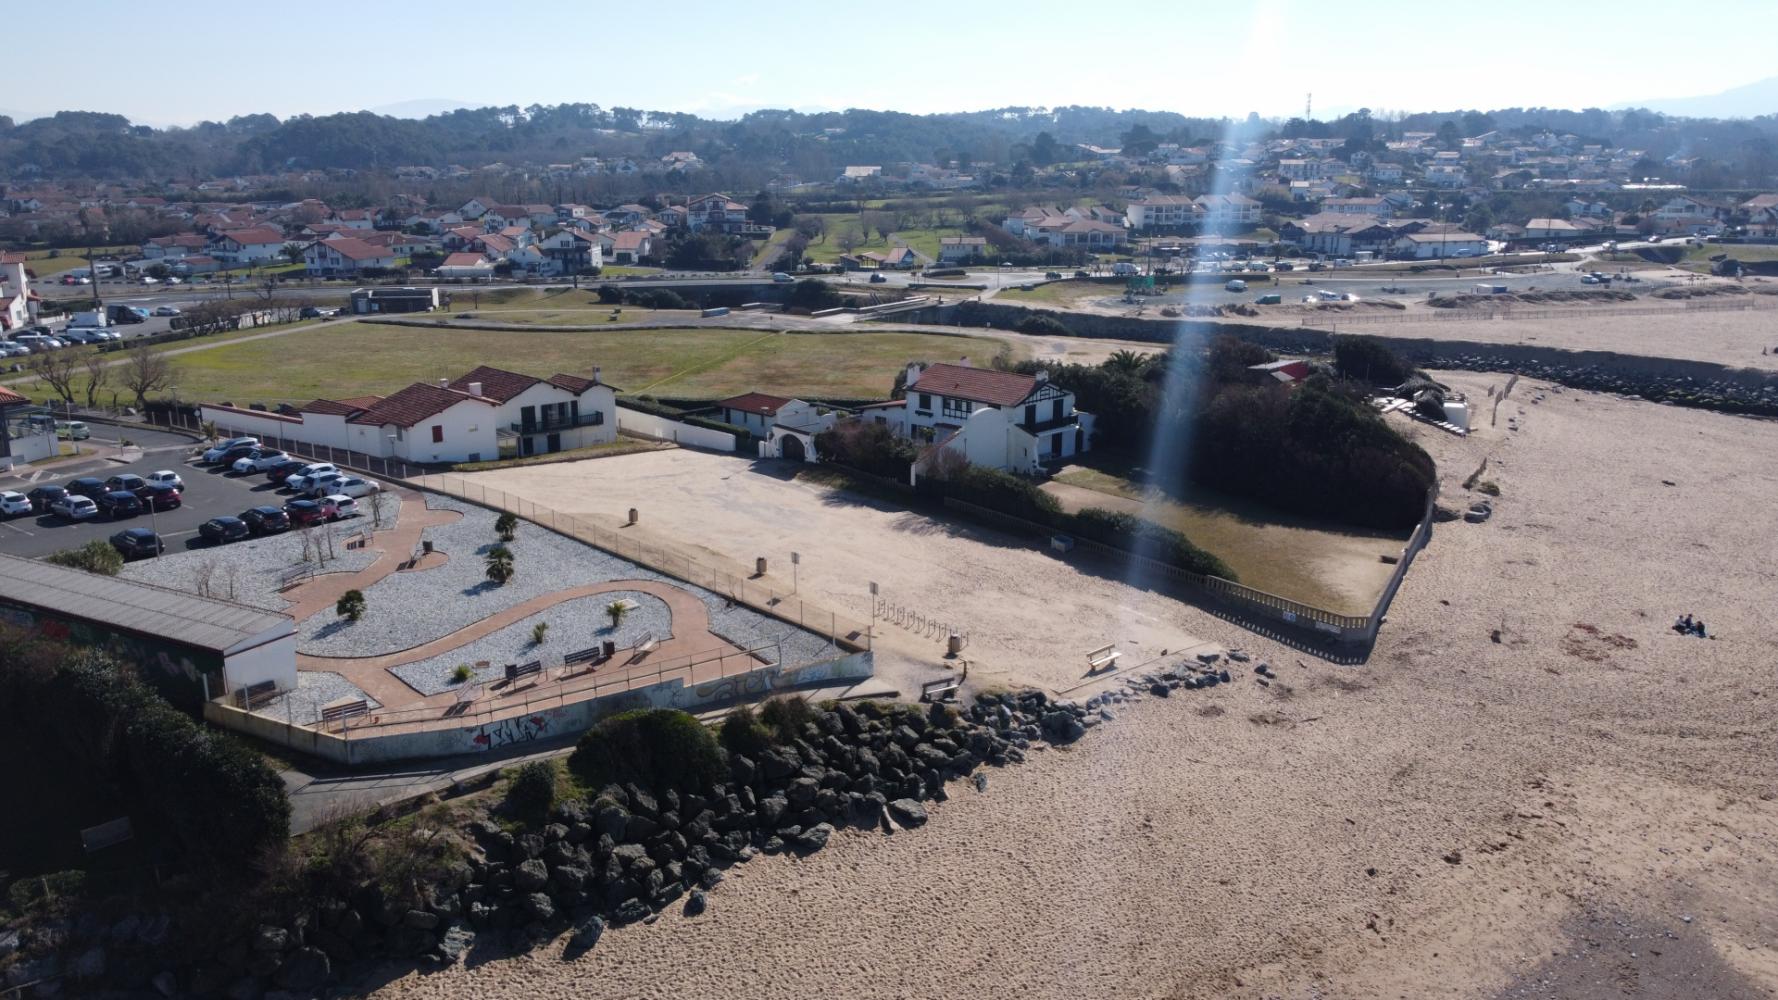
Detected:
[0,425,309,557]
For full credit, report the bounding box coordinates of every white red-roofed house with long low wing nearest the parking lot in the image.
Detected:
[201,365,617,464]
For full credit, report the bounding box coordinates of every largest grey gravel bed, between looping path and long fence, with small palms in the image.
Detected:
[297,495,830,667]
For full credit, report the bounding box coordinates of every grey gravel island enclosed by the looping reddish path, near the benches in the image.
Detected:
[389,591,672,694]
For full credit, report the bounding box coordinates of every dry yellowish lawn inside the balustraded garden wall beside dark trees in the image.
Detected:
[1056,466,1406,614]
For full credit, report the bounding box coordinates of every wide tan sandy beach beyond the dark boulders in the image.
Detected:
[368,374,1778,1000]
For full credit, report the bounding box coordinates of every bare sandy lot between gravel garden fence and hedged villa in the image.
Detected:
[448,450,1223,692]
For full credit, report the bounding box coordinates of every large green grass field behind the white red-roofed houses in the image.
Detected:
[147,324,1005,404]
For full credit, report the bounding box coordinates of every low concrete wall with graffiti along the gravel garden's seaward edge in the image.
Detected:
[204,651,875,765]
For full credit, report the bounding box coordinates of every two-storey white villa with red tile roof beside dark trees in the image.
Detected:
[896,358,1093,473]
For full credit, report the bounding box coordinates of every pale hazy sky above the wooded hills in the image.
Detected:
[13,0,1778,125]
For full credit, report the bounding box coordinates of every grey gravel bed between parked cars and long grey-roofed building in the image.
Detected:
[119,504,400,610]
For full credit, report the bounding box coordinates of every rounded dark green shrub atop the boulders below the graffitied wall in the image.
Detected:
[567,708,727,788]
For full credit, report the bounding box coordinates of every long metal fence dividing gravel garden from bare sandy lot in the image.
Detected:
[409,475,871,651]
